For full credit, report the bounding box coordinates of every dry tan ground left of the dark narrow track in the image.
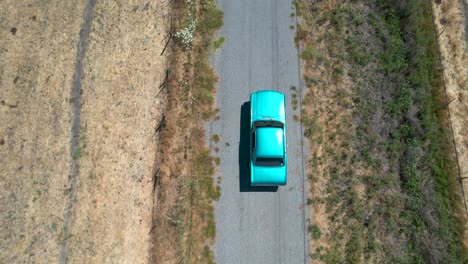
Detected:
[0,1,84,263]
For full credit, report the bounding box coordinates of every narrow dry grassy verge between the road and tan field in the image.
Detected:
[155,0,224,263]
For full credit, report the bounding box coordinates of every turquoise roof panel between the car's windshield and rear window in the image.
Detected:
[255,127,284,158]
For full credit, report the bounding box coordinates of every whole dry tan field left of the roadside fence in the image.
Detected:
[0,0,168,263]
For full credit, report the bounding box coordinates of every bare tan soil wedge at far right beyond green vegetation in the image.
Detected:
[432,1,468,246]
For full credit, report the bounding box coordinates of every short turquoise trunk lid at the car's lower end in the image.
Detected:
[250,164,286,185]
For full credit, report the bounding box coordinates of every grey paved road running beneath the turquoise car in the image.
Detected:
[208,0,308,264]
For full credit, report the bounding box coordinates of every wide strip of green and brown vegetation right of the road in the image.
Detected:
[295,0,467,263]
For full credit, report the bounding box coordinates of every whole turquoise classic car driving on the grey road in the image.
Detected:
[250,90,287,186]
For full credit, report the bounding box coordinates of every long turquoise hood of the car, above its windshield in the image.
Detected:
[250,90,285,123]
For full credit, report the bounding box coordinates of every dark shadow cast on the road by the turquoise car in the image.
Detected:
[239,101,278,192]
